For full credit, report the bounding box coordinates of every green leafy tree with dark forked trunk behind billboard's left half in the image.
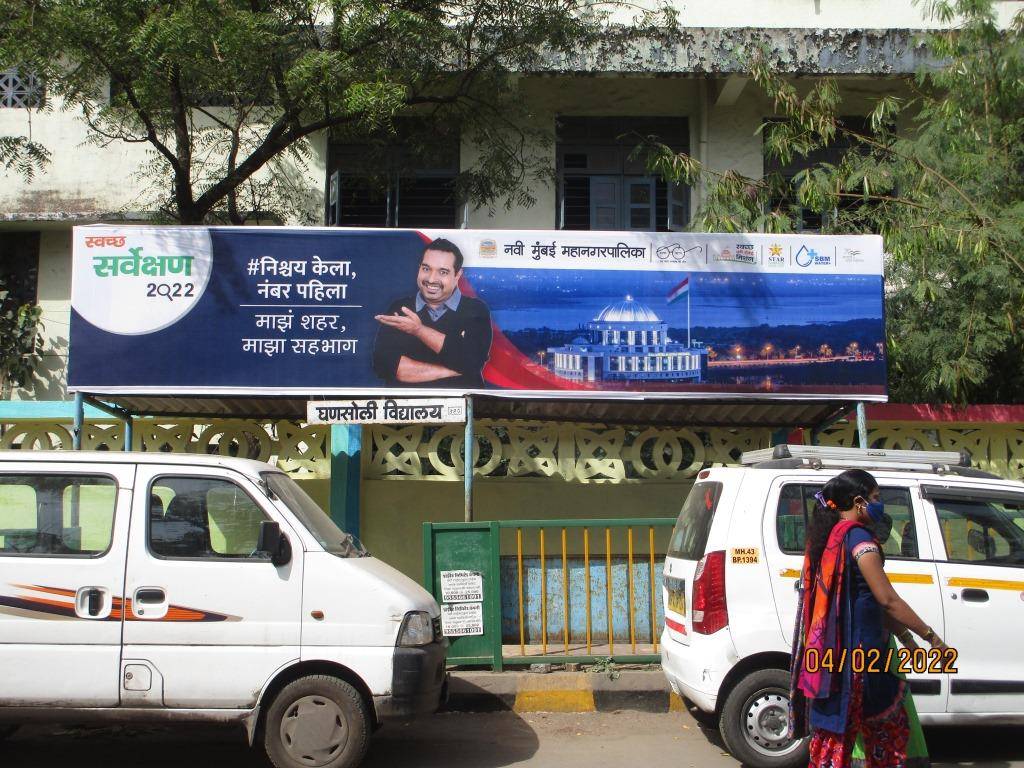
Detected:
[0,0,675,223]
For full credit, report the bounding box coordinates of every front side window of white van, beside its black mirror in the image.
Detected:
[148,476,267,559]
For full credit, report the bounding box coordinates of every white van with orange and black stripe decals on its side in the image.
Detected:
[0,451,447,768]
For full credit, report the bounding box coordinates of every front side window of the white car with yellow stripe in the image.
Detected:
[934,498,1024,566]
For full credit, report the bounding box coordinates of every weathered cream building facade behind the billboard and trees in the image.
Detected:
[0,0,1024,399]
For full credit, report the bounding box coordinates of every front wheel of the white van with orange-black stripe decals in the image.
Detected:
[263,675,370,768]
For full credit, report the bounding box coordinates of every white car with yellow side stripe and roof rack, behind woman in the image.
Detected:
[662,445,1024,768]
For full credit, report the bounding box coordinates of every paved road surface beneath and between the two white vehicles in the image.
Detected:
[0,712,1024,768]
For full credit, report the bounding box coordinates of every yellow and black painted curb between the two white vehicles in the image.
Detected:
[441,670,685,713]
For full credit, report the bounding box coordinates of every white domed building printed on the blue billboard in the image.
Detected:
[548,296,708,383]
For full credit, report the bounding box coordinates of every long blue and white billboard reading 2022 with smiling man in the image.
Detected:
[69,226,886,400]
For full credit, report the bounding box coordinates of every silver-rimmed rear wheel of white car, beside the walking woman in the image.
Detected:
[718,670,808,768]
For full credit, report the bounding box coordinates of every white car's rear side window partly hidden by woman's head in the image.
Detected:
[775,483,920,559]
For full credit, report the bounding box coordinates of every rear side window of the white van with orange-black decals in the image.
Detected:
[0,474,118,557]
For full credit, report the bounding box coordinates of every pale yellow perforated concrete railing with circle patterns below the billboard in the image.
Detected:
[0,418,1024,483]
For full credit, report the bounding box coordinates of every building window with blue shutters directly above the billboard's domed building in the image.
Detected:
[556,117,690,232]
